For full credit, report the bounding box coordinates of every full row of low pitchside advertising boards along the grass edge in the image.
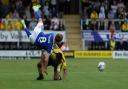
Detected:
[0,50,128,59]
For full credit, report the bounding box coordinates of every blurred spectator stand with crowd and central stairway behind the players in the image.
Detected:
[0,0,128,56]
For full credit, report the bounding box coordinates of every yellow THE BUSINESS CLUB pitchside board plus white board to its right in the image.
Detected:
[74,50,128,59]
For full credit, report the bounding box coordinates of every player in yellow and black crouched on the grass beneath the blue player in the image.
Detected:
[48,44,67,80]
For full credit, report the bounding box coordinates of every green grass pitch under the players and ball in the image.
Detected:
[0,59,128,89]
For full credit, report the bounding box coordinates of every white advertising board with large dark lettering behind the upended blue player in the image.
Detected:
[0,31,66,42]
